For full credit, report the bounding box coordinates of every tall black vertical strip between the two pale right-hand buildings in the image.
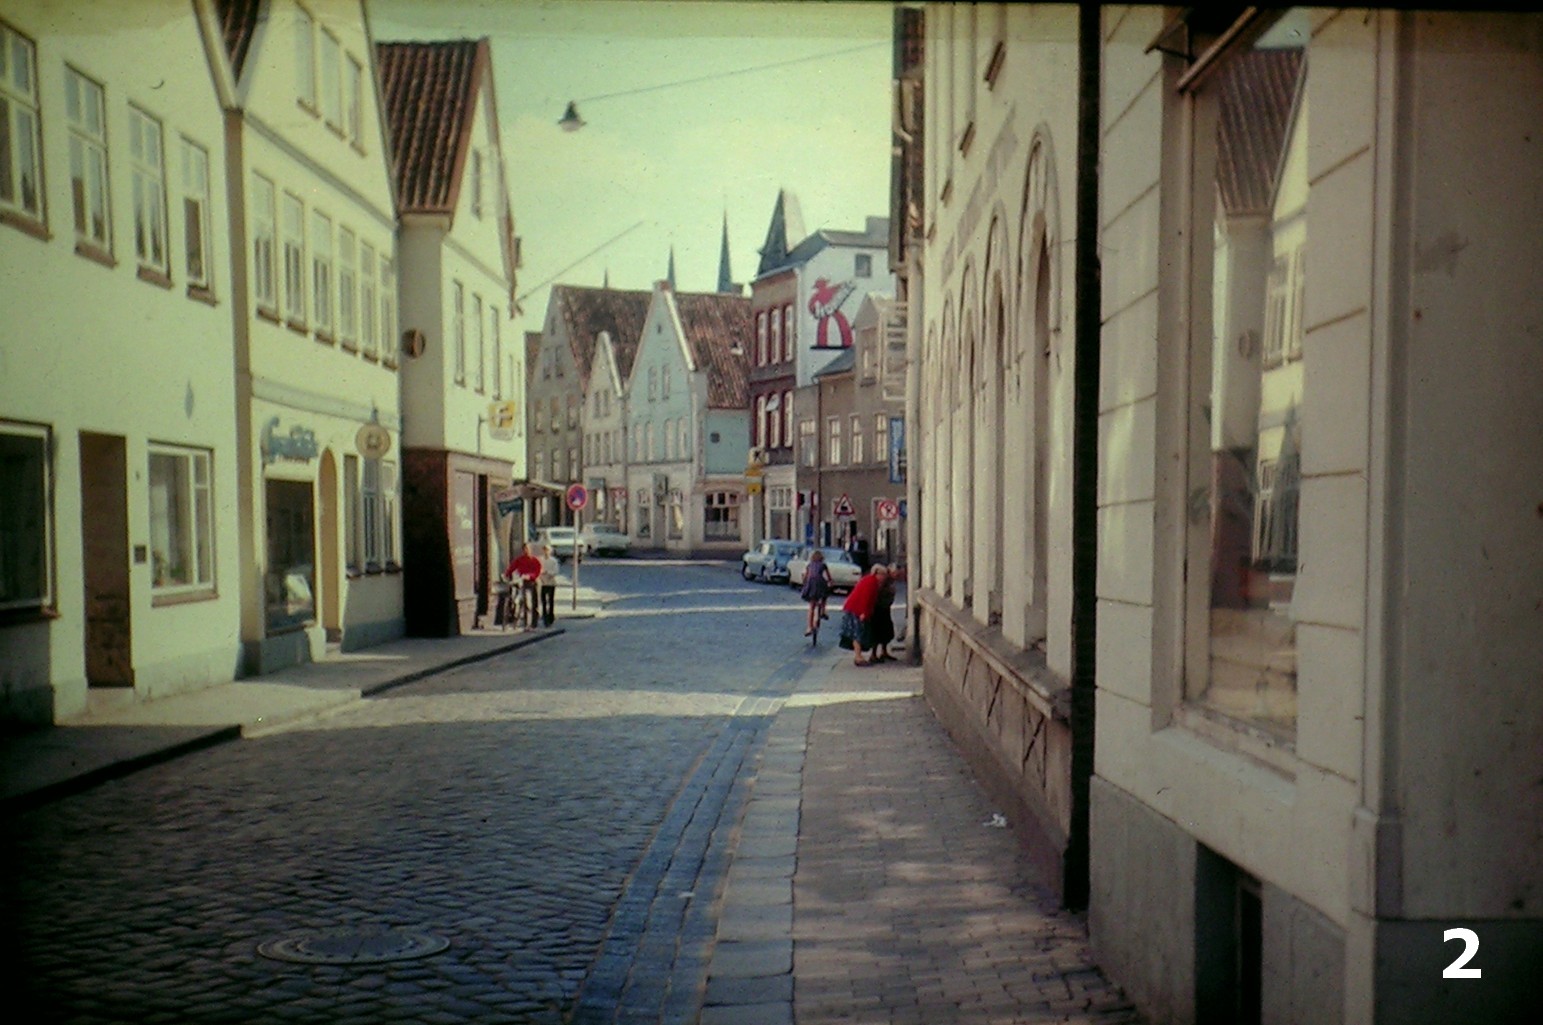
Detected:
[1063,0,1103,909]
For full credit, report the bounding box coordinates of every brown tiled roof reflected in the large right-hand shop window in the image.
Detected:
[1216,49,1302,213]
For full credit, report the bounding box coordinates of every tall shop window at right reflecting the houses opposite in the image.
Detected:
[1176,9,1308,744]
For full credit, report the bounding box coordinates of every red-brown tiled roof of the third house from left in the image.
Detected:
[375,39,489,213]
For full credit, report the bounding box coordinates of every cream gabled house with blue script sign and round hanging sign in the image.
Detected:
[216,0,403,673]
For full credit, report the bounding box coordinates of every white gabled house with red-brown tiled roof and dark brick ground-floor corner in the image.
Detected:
[375,39,526,636]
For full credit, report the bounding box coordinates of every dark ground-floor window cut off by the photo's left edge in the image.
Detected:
[0,420,54,610]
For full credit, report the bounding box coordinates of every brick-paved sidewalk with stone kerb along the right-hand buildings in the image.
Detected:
[701,658,1140,1025]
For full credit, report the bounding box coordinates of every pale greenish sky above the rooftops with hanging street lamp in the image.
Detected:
[369,0,892,339]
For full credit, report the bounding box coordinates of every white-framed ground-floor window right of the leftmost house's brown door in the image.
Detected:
[150,445,214,594]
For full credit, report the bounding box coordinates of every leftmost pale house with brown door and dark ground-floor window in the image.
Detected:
[0,0,239,724]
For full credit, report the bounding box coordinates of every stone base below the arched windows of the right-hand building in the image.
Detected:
[917,591,1071,897]
